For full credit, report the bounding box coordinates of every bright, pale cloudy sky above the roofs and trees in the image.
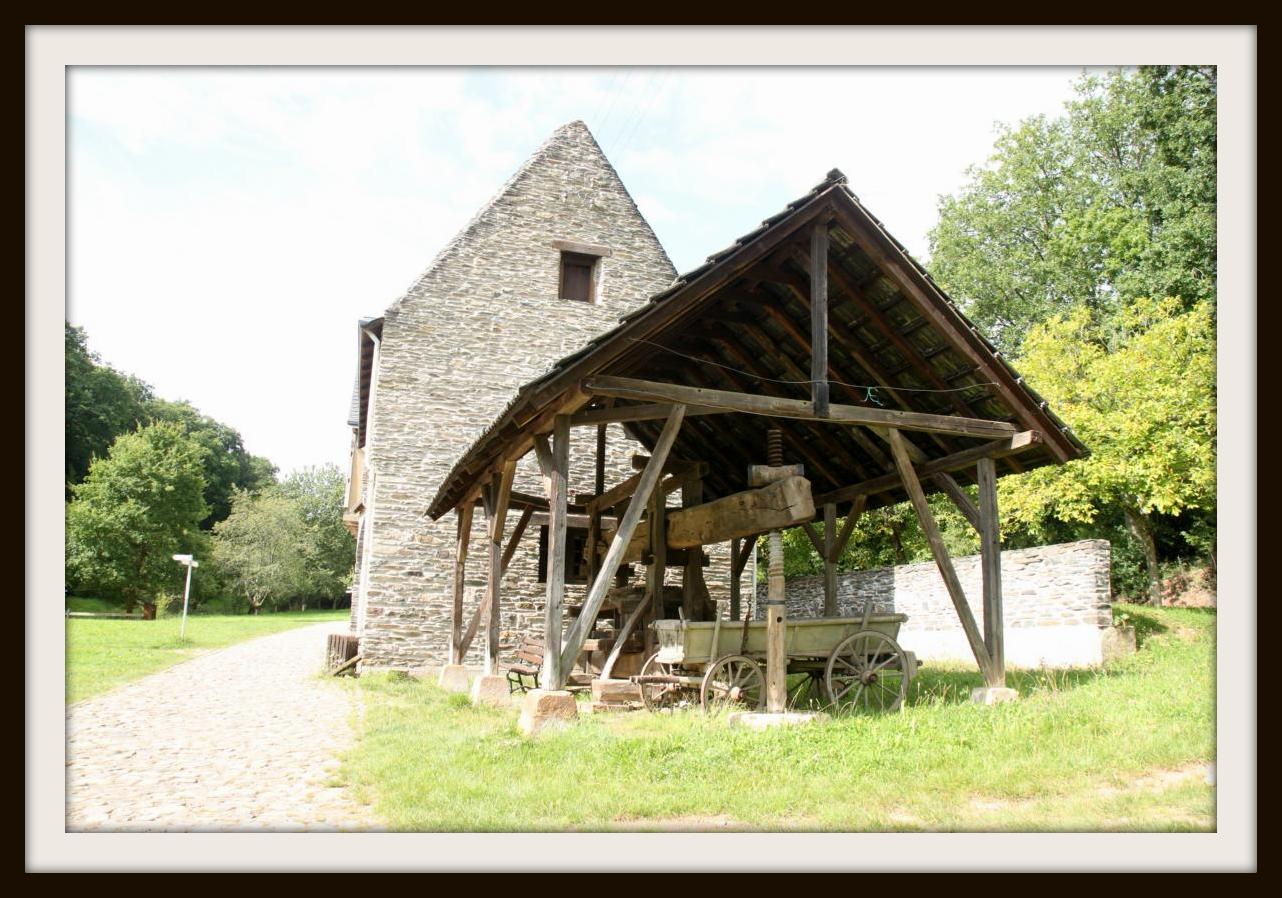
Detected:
[67,68,1081,475]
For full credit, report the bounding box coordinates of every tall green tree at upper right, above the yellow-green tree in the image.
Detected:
[931,67,1215,354]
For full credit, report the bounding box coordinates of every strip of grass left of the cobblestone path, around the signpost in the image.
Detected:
[67,599,350,702]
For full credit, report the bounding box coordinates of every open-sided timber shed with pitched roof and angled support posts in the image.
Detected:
[428,171,1087,706]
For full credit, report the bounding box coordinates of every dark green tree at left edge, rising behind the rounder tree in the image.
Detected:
[64,322,151,498]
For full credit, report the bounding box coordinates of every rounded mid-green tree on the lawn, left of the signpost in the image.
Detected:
[67,423,209,618]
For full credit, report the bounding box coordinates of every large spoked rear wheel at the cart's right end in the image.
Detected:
[823,630,913,712]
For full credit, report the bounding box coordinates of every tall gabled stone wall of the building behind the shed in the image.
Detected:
[354,122,746,668]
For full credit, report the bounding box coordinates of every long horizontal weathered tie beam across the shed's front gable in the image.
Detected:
[583,376,1017,439]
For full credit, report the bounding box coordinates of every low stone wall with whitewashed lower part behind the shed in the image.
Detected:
[756,540,1117,667]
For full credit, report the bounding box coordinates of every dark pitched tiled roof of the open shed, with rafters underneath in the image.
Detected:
[427,169,1087,518]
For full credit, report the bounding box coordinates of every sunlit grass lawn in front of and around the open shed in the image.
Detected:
[342,606,1215,831]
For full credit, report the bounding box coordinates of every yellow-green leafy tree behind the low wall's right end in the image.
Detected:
[1000,299,1215,600]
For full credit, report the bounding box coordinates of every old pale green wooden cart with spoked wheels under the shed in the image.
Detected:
[632,613,917,713]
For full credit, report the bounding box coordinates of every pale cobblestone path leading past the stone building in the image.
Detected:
[67,622,378,831]
